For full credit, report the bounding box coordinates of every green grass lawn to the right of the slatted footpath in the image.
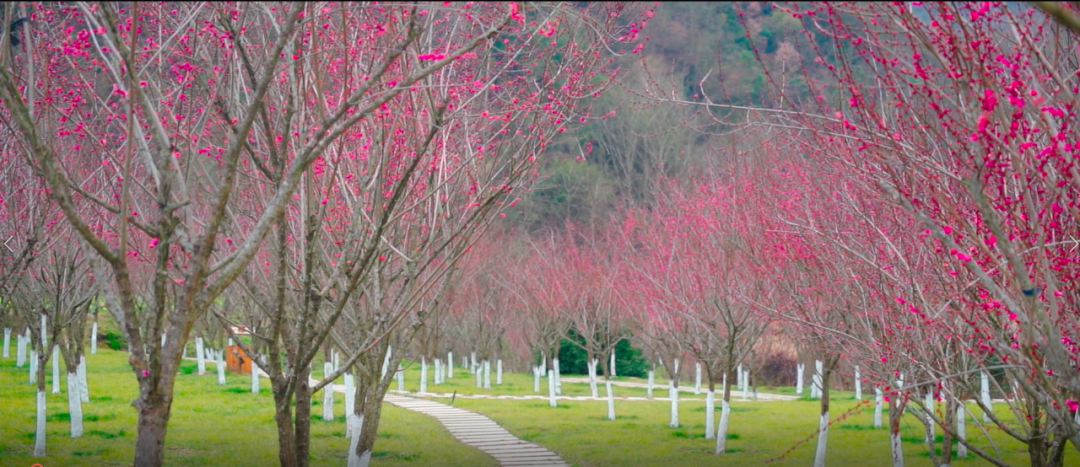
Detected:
[434,397,1067,467]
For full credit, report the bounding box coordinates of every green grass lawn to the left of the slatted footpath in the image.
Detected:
[0,348,497,467]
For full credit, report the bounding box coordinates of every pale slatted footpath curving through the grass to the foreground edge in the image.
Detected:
[383,395,568,467]
